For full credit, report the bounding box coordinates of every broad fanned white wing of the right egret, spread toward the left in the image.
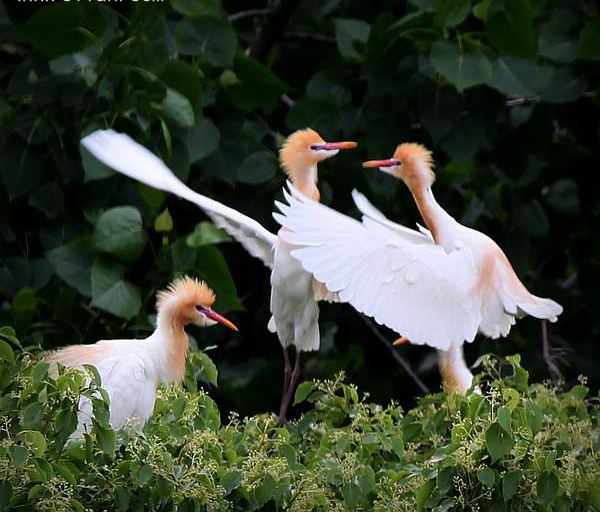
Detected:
[274,187,481,349]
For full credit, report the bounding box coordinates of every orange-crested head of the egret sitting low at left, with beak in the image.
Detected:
[156,276,238,331]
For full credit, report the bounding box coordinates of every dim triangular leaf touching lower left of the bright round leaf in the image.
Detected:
[47,238,94,297]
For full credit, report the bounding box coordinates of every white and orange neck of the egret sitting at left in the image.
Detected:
[156,308,190,384]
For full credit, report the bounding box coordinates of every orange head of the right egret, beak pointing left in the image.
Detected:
[363,142,435,188]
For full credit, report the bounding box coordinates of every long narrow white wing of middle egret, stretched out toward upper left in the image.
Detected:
[81,130,277,267]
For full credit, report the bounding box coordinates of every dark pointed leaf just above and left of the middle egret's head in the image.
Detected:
[225,55,289,110]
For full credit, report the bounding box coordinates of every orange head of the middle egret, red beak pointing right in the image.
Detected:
[279,128,357,182]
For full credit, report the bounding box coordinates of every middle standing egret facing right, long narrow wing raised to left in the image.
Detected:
[81,128,356,423]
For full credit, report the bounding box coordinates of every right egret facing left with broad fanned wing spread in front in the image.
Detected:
[275,144,562,392]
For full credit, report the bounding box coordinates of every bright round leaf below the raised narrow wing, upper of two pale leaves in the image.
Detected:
[94,206,146,261]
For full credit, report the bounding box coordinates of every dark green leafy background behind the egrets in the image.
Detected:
[0,0,600,424]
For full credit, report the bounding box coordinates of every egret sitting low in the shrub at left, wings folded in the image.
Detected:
[46,276,237,437]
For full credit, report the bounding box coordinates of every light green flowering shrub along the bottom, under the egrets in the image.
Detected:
[0,328,600,512]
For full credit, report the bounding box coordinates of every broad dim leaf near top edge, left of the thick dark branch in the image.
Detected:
[175,16,237,67]
